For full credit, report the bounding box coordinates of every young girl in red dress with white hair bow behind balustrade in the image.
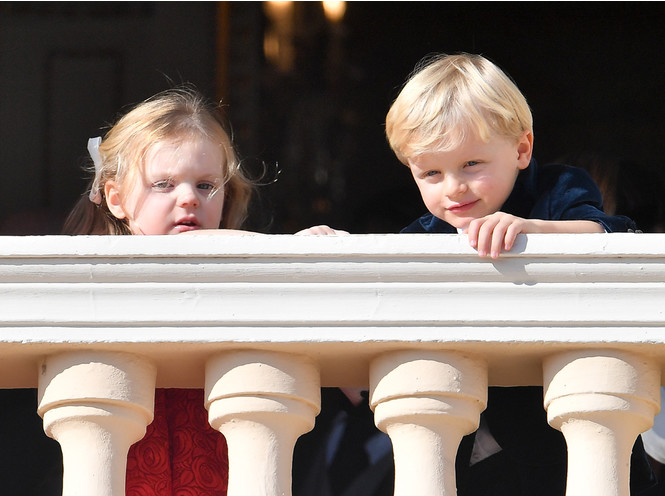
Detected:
[63,89,344,496]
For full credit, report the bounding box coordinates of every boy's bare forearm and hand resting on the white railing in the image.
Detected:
[466,212,605,258]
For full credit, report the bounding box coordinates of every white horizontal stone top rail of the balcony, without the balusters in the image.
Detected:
[0,233,665,387]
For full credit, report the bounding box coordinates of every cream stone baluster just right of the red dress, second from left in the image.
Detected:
[205,351,321,496]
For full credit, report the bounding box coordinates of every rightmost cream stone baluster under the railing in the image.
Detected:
[543,350,660,496]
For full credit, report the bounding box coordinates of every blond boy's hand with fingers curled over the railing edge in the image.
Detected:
[466,212,529,258]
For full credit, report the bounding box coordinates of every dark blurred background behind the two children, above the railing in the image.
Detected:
[0,1,665,234]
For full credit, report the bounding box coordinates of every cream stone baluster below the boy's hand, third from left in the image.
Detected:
[370,350,487,496]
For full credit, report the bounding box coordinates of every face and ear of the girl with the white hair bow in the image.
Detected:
[106,139,226,234]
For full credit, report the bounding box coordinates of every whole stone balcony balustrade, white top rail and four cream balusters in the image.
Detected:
[0,234,665,496]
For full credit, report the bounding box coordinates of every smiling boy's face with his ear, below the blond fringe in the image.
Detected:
[409,131,533,229]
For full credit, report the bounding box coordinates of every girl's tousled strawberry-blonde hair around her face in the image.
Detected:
[63,87,253,234]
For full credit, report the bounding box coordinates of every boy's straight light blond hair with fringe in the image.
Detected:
[386,54,533,165]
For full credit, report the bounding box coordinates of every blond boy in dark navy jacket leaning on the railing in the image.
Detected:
[386,54,635,258]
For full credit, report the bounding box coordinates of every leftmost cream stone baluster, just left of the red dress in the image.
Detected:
[38,351,156,496]
